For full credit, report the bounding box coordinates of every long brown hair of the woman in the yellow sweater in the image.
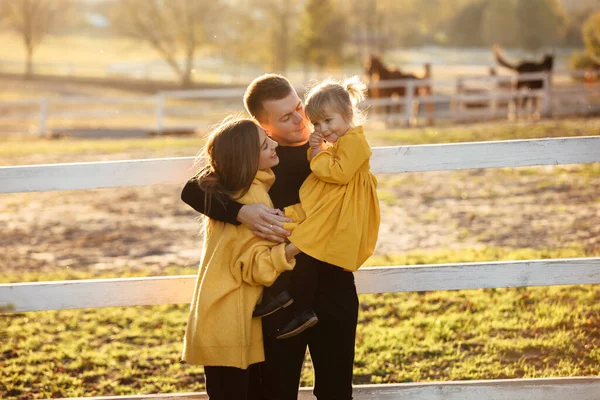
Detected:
[195,116,260,211]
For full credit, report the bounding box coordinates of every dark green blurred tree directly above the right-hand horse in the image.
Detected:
[515,0,567,51]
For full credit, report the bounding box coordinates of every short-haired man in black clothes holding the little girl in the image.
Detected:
[181,74,358,400]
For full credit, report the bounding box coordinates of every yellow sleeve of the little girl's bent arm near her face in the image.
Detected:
[310,131,372,185]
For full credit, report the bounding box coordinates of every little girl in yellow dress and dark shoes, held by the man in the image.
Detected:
[254,77,380,339]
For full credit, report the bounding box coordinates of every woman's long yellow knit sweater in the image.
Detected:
[182,169,295,369]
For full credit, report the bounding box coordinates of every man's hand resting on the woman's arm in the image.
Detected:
[237,203,292,243]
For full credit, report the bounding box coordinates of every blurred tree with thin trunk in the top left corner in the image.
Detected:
[0,0,69,78]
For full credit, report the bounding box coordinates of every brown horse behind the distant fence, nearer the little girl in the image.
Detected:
[365,55,433,124]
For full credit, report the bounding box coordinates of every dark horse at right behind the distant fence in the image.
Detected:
[493,45,554,119]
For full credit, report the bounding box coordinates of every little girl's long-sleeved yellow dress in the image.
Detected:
[284,126,380,271]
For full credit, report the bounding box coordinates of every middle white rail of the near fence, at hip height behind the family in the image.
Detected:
[0,258,600,312]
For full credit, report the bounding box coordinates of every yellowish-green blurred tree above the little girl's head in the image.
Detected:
[298,0,346,68]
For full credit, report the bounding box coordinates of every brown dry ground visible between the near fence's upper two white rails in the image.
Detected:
[0,139,600,276]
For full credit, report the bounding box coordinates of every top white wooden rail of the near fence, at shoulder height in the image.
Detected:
[0,136,600,193]
